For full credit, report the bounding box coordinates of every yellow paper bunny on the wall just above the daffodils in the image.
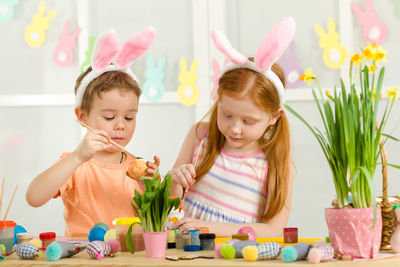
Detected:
[315,18,347,69]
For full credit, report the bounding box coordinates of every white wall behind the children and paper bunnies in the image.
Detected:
[0,0,400,237]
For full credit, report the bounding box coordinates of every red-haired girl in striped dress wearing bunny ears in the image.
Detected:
[170,18,294,237]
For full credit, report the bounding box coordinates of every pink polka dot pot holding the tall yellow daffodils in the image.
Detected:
[325,206,382,258]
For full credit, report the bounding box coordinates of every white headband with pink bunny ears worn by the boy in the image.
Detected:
[75,27,156,107]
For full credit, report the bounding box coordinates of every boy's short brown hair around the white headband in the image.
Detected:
[75,67,142,113]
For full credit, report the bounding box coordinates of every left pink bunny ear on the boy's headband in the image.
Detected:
[92,30,120,72]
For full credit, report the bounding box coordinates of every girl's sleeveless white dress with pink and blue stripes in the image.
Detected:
[183,136,268,223]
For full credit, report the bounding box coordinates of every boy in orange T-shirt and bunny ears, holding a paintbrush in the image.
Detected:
[26,28,160,237]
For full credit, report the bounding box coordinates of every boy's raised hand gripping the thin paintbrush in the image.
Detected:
[73,130,113,162]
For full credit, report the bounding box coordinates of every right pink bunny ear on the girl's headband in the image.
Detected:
[255,17,296,70]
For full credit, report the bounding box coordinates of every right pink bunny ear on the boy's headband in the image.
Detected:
[117,27,156,68]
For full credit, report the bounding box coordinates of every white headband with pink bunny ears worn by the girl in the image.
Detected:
[211,17,296,107]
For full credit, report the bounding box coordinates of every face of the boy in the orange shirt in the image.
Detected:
[82,88,138,152]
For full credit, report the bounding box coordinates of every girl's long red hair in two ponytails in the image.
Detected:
[196,64,292,221]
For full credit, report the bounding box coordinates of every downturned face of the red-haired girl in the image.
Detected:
[217,95,279,152]
